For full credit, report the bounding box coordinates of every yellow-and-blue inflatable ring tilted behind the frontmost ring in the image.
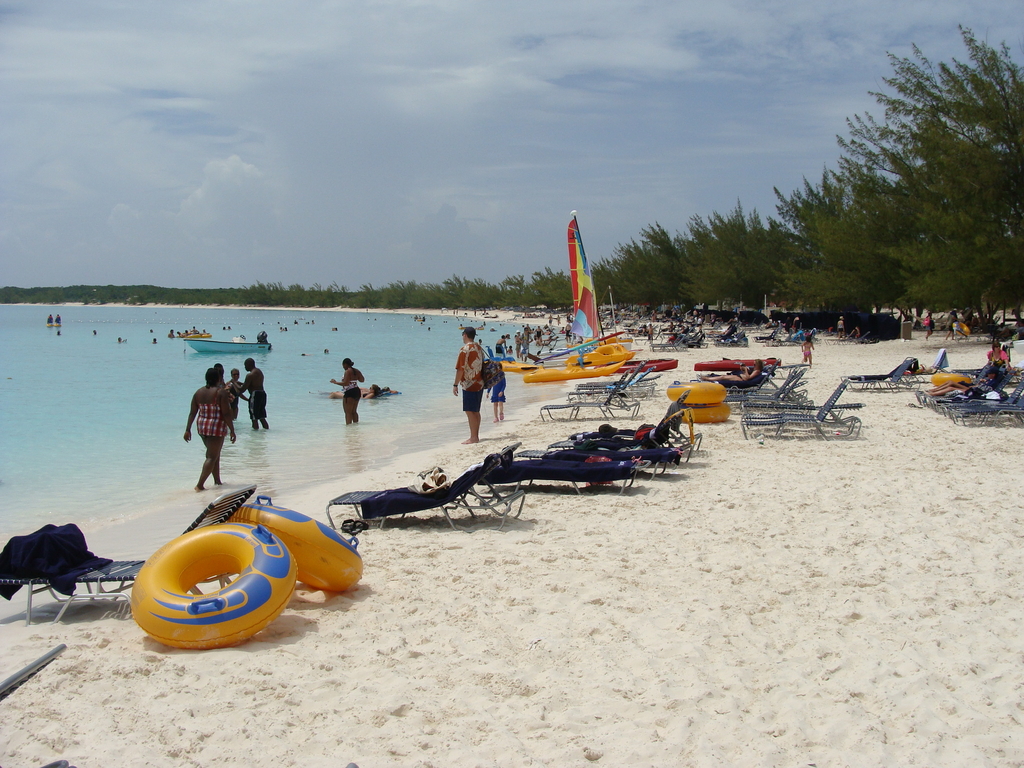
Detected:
[231,496,362,592]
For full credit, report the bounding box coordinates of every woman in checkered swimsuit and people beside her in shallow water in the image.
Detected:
[184,357,270,490]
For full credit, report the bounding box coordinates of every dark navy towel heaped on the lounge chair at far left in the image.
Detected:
[0,522,114,600]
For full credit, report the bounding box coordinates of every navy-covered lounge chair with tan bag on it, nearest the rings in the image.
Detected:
[327,454,525,530]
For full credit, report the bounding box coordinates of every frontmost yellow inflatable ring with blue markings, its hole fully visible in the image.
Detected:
[131,522,295,648]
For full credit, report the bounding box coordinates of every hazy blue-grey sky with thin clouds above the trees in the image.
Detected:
[0,0,1024,290]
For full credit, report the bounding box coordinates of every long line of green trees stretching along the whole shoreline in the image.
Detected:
[0,28,1024,322]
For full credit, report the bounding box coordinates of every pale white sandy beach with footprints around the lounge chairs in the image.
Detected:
[0,331,1024,768]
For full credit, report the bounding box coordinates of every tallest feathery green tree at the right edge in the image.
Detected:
[840,29,1024,313]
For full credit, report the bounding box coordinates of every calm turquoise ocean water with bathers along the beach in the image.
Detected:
[0,305,552,540]
